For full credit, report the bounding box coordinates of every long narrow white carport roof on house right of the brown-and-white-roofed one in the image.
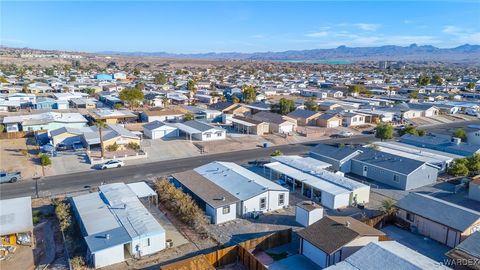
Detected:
[265,162,351,195]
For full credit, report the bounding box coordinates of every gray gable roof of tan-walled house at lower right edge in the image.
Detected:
[396,193,480,232]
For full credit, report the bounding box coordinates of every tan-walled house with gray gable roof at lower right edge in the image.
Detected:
[396,193,480,247]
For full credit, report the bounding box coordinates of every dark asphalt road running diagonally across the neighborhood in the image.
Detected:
[0,121,480,199]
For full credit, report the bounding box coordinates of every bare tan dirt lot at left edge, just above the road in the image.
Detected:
[0,138,42,178]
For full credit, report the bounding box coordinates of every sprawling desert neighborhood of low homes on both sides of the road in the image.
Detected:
[0,61,480,270]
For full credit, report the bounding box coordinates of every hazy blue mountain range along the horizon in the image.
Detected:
[100,44,480,63]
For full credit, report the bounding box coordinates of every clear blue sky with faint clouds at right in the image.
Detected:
[0,0,480,53]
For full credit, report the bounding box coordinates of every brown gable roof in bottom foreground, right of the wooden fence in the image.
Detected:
[298,216,385,254]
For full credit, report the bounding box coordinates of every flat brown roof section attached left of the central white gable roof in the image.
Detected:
[172,170,239,208]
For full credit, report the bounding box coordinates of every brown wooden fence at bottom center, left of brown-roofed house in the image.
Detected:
[160,229,292,270]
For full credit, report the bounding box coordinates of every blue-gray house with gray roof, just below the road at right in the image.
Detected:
[310,144,438,190]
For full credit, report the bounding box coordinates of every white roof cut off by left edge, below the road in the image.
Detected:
[0,197,33,236]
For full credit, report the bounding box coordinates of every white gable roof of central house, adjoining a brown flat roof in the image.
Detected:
[194,161,288,200]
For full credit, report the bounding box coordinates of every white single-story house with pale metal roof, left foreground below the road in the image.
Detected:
[71,183,166,268]
